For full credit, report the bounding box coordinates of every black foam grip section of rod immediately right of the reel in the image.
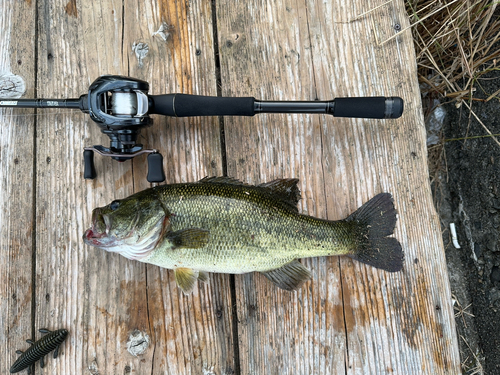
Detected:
[149,94,255,117]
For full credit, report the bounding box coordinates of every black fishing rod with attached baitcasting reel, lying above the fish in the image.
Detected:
[0,75,403,182]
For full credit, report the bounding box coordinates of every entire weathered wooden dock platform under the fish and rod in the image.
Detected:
[0,0,461,375]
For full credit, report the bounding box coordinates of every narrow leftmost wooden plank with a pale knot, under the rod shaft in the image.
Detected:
[0,1,35,372]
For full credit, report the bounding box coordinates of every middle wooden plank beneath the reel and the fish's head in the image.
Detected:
[30,0,235,374]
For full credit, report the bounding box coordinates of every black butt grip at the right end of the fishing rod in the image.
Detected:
[332,96,404,119]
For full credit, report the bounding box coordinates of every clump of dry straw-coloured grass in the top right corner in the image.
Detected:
[406,0,500,101]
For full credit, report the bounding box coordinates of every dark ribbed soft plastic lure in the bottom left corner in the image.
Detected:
[10,328,68,374]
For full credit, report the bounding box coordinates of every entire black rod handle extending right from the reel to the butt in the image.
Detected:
[148,94,404,119]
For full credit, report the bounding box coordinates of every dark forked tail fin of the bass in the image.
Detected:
[346,193,404,272]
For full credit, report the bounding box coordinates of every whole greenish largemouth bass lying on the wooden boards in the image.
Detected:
[83,177,404,294]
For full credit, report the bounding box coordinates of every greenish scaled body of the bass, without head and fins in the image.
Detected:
[144,184,355,273]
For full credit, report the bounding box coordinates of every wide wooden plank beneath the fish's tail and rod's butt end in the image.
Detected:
[217,0,460,374]
